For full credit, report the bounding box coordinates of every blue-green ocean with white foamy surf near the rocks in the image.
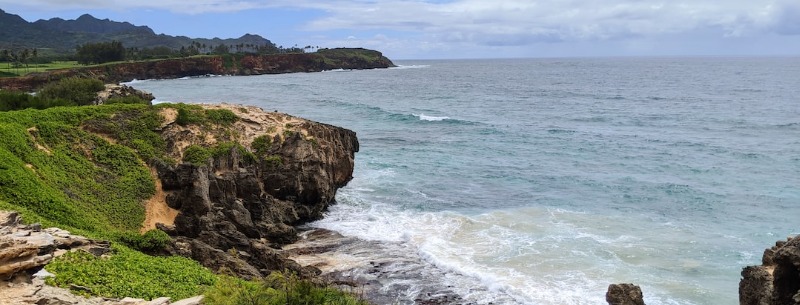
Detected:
[131,57,800,305]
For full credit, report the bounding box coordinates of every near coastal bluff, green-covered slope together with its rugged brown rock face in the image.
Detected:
[0,99,359,296]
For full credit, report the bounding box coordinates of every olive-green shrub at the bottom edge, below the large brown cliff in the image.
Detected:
[204,272,368,305]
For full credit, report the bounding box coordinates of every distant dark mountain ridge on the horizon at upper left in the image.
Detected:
[0,9,274,53]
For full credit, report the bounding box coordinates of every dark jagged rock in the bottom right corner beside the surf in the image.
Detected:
[739,236,800,305]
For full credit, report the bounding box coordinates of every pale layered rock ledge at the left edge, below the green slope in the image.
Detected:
[0,211,110,280]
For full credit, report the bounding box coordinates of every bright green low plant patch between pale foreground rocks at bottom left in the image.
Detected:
[47,245,217,300]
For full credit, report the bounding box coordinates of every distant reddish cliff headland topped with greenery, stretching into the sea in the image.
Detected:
[0,48,394,91]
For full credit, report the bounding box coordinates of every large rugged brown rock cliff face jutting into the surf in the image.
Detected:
[154,106,358,278]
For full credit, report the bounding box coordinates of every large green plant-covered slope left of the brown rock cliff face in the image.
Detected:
[0,105,158,235]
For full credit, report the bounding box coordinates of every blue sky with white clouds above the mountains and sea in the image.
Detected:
[0,0,800,60]
